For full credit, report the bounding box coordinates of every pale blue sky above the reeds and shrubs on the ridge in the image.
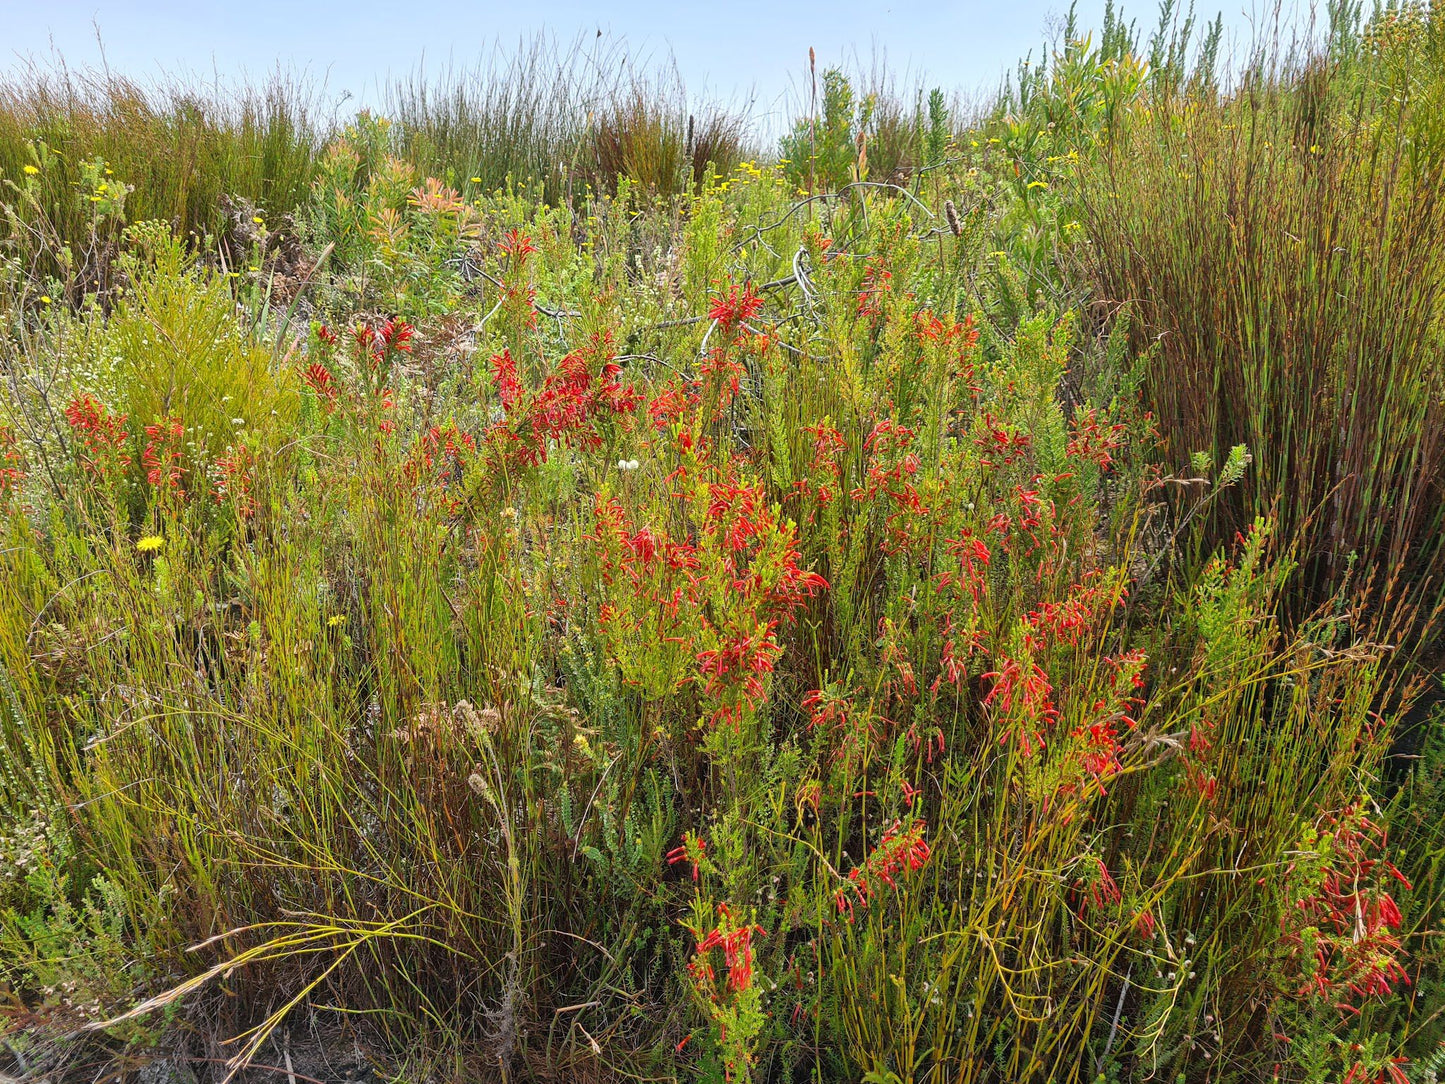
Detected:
[0,0,1299,124]
